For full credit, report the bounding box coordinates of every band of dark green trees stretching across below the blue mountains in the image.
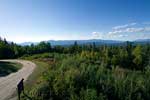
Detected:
[0,38,150,70]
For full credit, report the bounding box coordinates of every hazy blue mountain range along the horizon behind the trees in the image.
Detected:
[20,39,150,46]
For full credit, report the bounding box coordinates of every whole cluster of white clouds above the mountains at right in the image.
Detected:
[92,23,150,40]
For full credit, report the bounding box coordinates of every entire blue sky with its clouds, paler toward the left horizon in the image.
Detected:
[0,0,150,43]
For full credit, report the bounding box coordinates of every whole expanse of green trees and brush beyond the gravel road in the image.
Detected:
[0,39,150,100]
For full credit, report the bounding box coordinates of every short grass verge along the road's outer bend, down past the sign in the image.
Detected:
[13,53,72,100]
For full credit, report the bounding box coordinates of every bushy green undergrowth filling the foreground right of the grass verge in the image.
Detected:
[20,54,150,100]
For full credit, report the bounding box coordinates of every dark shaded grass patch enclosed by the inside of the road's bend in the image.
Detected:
[0,61,22,77]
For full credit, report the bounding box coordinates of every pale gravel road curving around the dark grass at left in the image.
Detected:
[0,60,36,100]
